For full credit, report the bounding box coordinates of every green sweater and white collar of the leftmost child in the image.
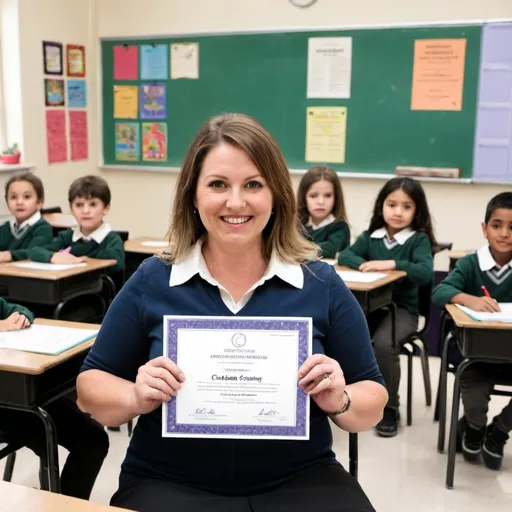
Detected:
[0,212,53,261]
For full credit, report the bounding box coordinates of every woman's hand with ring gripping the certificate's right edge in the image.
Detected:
[299,354,346,413]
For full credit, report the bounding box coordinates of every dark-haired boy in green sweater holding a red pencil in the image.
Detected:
[432,192,512,470]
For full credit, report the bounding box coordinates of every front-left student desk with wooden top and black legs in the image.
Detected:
[0,319,99,494]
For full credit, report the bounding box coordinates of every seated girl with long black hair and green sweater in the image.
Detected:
[338,177,436,437]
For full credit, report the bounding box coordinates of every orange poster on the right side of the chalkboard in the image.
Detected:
[411,39,466,110]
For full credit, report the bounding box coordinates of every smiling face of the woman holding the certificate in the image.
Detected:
[194,144,272,248]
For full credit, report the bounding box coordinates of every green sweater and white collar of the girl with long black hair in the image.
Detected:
[338,228,434,315]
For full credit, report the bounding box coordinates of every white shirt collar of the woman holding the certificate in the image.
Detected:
[169,240,304,314]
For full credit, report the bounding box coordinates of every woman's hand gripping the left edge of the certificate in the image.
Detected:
[134,356,185,414]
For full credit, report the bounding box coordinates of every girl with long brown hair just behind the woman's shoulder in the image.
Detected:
[298,167,350,258]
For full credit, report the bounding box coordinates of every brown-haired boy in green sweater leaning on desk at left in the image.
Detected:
[28,176,125,274]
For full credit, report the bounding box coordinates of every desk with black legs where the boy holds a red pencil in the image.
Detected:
[438,304,512,489]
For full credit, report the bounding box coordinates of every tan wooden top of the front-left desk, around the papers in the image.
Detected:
[0,318,100,374]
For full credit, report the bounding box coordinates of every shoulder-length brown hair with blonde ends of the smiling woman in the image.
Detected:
[163,114,318,263]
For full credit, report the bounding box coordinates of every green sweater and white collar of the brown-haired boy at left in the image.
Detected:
[28,224,125,274]
